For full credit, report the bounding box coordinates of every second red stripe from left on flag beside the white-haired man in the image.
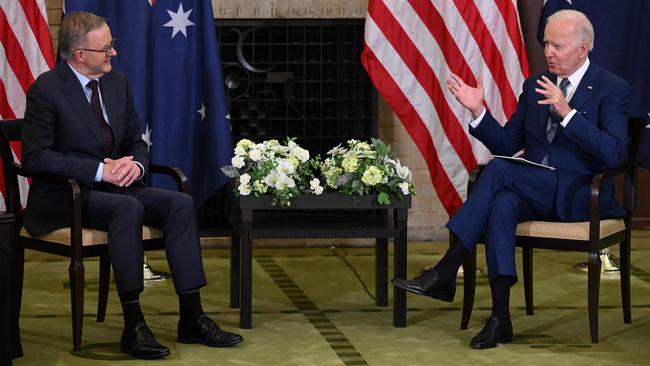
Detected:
[369,3,476,170]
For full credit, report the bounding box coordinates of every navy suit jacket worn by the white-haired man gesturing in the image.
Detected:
[470,62,629,221]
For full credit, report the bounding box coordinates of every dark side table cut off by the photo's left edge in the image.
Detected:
[0,212,23,365]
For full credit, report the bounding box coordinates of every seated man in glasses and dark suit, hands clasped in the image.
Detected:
[22,12,242,358]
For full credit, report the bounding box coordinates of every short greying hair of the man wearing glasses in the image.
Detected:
[59,11,106,60]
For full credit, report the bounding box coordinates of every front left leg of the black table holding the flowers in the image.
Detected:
[239,210,253,329]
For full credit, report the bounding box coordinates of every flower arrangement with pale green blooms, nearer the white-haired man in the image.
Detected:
[320,138,415,204]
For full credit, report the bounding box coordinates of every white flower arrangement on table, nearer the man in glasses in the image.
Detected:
[221,139,323,206]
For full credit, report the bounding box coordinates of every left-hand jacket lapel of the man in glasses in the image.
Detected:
[57,62,109,149]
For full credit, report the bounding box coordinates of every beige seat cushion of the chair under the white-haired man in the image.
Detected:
[517,220,625,240]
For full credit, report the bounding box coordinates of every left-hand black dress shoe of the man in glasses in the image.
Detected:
[120,322,170,360]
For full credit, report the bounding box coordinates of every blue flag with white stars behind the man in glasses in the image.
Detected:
[63,0,233,205]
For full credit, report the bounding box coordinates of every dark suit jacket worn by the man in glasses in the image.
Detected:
[21,62,149,235]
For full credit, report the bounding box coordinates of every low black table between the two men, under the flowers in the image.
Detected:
[230,193,411,329]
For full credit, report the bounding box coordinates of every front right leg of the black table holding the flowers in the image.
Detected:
[393,208,408,328]
